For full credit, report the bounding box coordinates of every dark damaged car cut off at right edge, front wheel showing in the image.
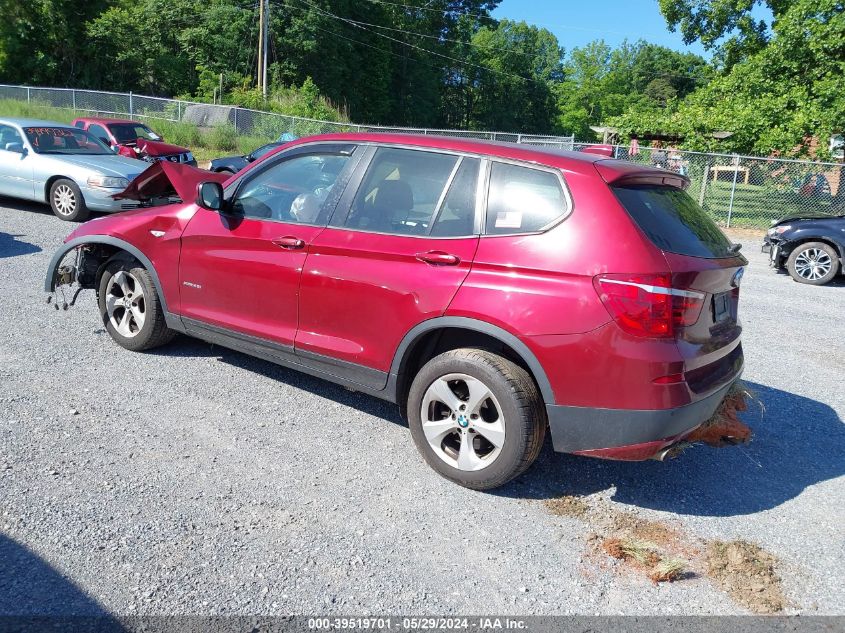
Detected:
[763,213,845,286]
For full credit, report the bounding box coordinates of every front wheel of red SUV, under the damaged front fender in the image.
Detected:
[97,259,176,352]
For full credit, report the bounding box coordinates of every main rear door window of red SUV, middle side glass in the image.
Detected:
[344,147,458,235]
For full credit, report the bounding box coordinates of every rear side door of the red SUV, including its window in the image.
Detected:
[296,147,482,388]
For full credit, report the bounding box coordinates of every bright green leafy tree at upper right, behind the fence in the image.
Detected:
[612,0,845,156]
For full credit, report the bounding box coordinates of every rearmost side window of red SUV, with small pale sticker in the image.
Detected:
[486,162,566,235]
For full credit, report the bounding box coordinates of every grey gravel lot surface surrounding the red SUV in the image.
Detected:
[0,199,845,615]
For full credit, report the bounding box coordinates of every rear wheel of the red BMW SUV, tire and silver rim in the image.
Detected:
[408,349,546,490]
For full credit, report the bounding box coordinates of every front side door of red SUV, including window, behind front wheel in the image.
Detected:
[179,145,355,351]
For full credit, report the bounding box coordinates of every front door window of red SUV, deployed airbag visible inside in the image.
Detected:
[232,154,349,224]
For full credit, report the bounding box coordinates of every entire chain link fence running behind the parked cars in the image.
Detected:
[0,85,845,229]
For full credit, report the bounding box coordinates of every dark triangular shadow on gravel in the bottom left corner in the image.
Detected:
[0,534,124,632]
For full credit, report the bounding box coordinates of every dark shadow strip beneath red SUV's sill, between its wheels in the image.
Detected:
[152,336,410,428]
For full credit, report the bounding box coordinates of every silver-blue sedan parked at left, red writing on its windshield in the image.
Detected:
[0,118,143,222]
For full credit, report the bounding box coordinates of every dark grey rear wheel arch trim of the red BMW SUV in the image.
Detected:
[390,317,554,415]
